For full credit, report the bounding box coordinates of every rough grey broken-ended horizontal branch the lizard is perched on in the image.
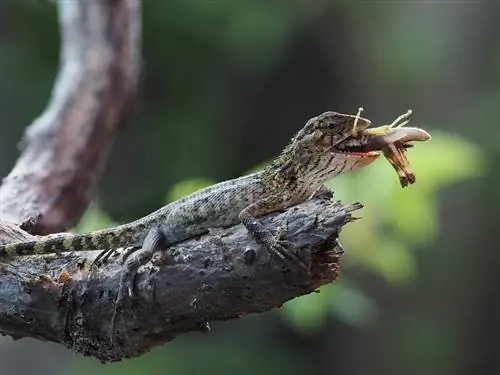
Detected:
[0,198,361,362]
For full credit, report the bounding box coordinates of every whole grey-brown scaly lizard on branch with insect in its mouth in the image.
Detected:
[0,108,430,332]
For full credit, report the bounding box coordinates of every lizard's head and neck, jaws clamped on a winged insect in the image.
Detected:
[268,108,430,190]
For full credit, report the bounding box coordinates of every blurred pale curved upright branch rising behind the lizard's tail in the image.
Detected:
[0,0,140,234]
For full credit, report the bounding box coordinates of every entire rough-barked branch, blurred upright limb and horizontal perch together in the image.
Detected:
[0,0,360,362]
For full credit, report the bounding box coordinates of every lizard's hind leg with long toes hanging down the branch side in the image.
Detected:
[111,227,168,341]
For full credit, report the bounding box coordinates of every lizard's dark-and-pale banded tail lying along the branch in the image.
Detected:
[0,228,137,256]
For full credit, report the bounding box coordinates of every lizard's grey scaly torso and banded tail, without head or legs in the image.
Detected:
[0,172,263,255]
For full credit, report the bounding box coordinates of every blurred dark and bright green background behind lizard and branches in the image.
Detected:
[0,0,500,375]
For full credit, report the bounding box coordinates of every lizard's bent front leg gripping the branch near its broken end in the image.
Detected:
[239,194,308,269]
